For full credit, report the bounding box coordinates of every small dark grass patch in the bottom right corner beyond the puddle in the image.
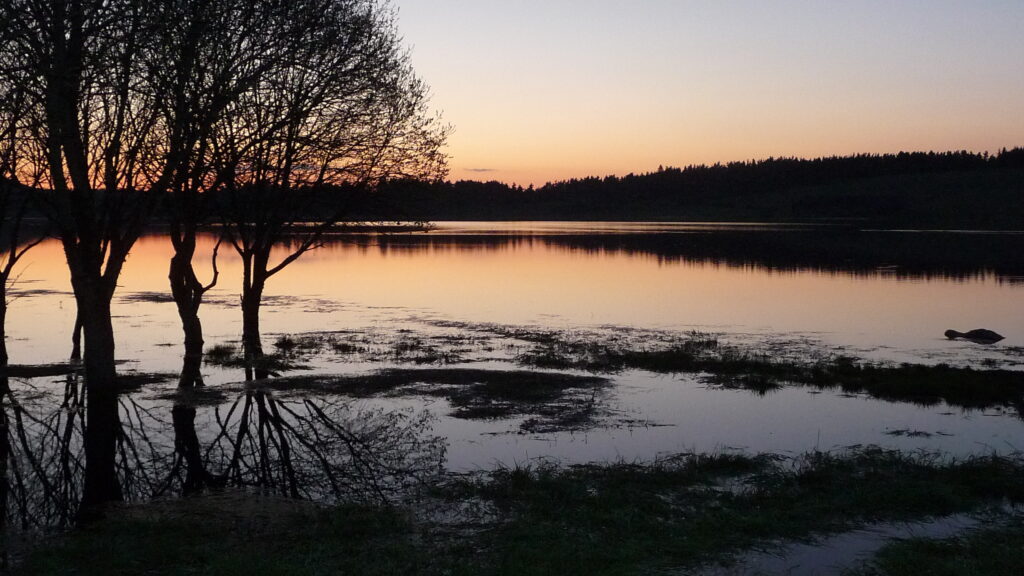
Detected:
[849,517,1024,576]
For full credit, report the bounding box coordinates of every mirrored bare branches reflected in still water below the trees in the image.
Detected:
[0,366,445,532]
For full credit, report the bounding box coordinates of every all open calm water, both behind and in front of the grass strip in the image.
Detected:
[7,222,1024,524]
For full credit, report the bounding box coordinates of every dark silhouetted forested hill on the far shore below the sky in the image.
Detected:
[357,148,1024,228]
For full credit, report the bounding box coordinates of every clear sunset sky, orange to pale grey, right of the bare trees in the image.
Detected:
[393,0,1024,186]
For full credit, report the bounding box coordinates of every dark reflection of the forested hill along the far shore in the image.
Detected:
[354,224,1024,282]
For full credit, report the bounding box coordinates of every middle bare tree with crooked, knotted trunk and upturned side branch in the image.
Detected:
[137,0,295,387]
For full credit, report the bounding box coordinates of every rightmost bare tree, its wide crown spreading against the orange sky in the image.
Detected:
[212,0,449,361]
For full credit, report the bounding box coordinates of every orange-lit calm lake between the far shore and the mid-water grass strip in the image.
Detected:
[8,222,1024,362]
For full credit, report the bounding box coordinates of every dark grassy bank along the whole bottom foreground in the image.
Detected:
[10,448,1024,575]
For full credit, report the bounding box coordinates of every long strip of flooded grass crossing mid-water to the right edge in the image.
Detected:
[220,323,1024,413]
